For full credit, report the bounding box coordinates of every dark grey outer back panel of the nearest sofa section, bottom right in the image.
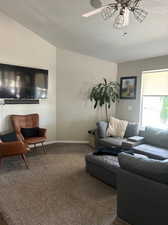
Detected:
[117,169,168,225]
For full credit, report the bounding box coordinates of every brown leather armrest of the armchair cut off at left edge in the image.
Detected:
[0,141,27,157]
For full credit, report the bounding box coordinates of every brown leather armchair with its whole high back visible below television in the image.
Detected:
[11,114,47,152]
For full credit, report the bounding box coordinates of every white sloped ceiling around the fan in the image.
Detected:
[0,0,168,62]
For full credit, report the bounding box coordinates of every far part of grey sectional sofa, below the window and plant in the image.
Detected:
[96,121,168,159]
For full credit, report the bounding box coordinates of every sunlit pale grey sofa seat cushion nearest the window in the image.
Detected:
[133,144,168,159]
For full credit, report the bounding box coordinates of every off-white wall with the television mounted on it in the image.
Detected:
[0,11,56,140]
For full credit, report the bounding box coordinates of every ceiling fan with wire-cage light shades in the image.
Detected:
[82,0,148,29]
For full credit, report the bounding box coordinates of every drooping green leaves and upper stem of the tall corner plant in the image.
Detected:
[89,78,120,121]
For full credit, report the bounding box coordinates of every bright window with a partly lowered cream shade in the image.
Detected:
[141,70,168,128]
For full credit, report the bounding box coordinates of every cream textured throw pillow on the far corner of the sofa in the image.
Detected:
[107,117,128,138]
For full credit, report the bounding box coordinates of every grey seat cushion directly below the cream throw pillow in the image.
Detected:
[99,137,125,147]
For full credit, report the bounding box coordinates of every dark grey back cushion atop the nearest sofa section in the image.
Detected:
[118,153,168,184]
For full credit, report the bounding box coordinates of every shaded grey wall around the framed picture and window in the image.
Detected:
[116,56,168,122]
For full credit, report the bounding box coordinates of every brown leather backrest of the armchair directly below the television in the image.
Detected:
[10,114,39,132]
